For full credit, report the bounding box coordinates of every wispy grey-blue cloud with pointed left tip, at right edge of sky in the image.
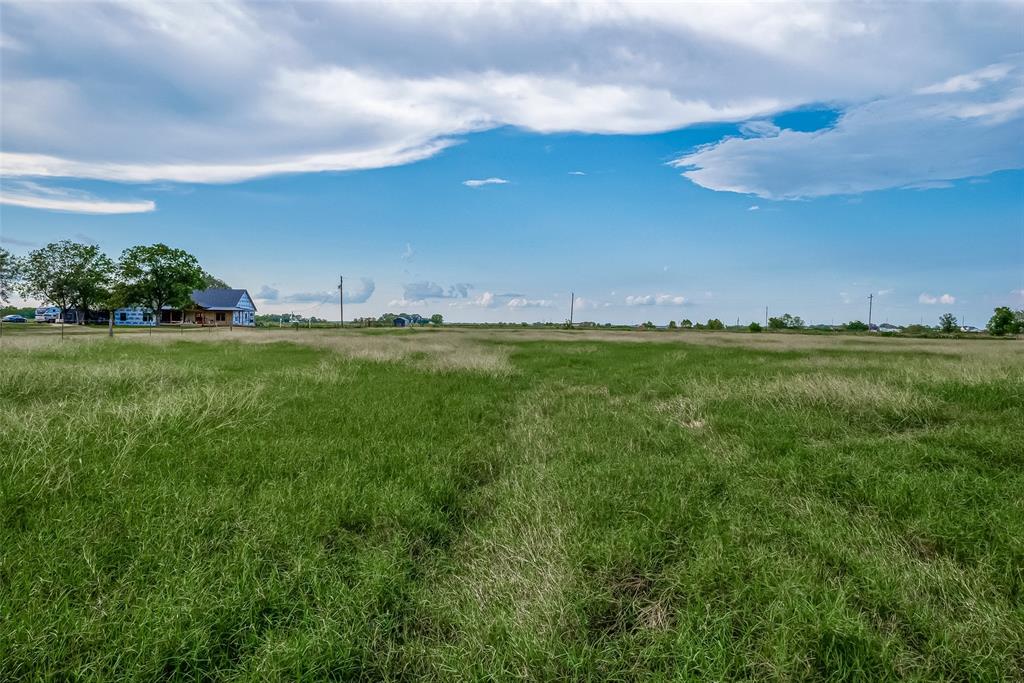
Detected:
[673,57,1024,200]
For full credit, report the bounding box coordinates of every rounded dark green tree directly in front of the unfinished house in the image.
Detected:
[118,244,206,315]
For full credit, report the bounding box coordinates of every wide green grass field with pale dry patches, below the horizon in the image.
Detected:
[0,326,1024,680]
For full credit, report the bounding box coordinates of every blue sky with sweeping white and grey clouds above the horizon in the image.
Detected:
[0,3,1024,325]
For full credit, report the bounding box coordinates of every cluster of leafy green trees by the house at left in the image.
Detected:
[0,240,227,323]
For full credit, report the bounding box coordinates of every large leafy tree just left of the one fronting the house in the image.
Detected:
[19,240,114,322]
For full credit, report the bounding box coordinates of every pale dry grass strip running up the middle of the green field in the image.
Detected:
[409,387,580,678]
